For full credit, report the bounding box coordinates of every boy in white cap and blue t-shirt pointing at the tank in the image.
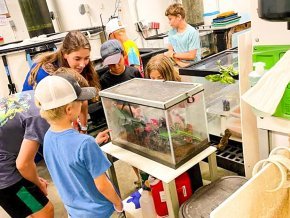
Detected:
[35,75,123,217]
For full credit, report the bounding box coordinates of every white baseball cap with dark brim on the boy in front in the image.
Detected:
[34,74,97,110]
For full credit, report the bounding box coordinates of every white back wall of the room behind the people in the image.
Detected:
[0,0,251,47]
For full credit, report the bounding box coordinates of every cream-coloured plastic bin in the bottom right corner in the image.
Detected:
[210,164,290,218]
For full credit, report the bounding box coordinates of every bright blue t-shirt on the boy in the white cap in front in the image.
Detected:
[44,129,114,218]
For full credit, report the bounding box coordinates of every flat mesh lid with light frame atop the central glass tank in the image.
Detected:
[99,78,203,109]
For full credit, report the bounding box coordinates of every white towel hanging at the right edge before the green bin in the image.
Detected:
[242,50,290,115]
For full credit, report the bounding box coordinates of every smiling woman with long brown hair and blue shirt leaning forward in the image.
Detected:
[22,31,100,133]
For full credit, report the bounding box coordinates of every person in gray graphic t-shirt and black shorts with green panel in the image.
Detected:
[0,91,54,217]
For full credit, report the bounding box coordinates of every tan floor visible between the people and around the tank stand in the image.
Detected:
[0,158,234,218]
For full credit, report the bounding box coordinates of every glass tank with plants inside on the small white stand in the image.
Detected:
[99,78,209,169]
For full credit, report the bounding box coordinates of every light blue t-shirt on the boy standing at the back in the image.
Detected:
[168,24,201,63]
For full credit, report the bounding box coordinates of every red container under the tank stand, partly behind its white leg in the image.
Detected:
[150,172,192,216]
